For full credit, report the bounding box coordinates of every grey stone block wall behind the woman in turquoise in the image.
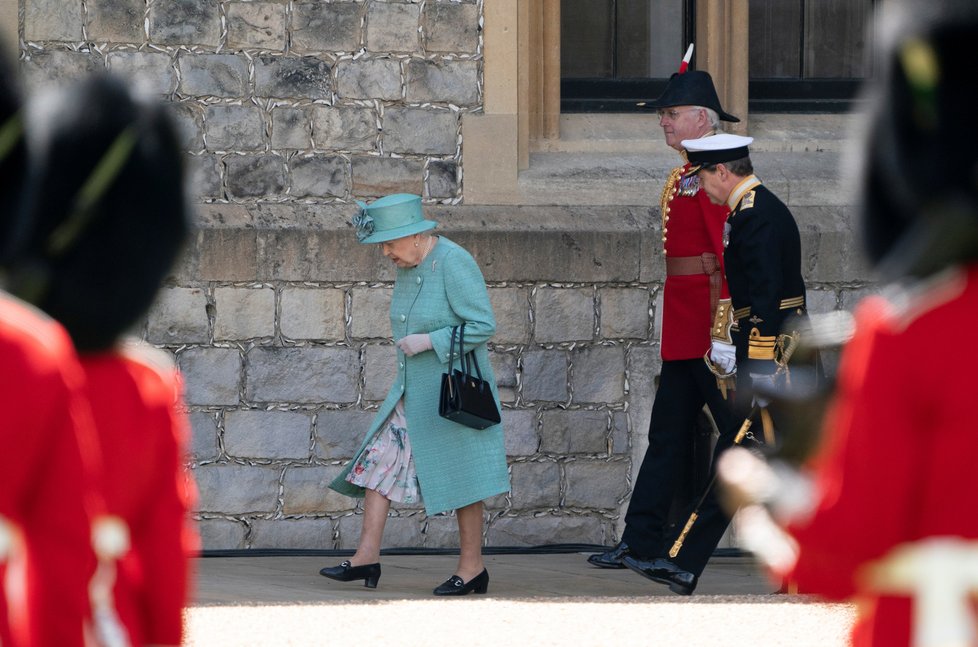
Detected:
[20,0,867,549]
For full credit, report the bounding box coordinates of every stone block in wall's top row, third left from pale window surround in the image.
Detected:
[292,2,363,52]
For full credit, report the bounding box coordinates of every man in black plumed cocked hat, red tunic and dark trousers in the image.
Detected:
[588,55,739,595]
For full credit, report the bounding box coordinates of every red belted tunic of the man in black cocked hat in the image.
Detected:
[660,163,729,360]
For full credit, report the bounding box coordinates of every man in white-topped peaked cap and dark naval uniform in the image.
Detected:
[623,134,805,595]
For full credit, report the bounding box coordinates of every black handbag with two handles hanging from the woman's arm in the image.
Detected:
[438,324,500,429]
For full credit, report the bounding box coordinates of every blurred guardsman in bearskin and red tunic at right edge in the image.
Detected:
[722,0,978,647]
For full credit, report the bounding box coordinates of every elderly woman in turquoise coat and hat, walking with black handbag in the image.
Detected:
[320,194,509,595]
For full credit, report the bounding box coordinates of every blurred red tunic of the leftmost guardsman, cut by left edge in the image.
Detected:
[0,293,99,647]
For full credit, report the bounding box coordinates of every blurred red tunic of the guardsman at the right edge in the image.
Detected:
[788,265,978,647]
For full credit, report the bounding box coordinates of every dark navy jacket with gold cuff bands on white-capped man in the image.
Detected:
[723,175,805,374]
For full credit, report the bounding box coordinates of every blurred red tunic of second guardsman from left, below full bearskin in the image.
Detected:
[82,346,198,645]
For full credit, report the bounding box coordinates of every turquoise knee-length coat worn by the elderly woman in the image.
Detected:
[330,236,509,515]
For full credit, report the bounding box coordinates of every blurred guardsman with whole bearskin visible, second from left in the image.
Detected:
[8,77,197,645]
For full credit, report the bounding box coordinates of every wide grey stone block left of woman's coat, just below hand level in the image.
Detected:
[245,347,360,402]
